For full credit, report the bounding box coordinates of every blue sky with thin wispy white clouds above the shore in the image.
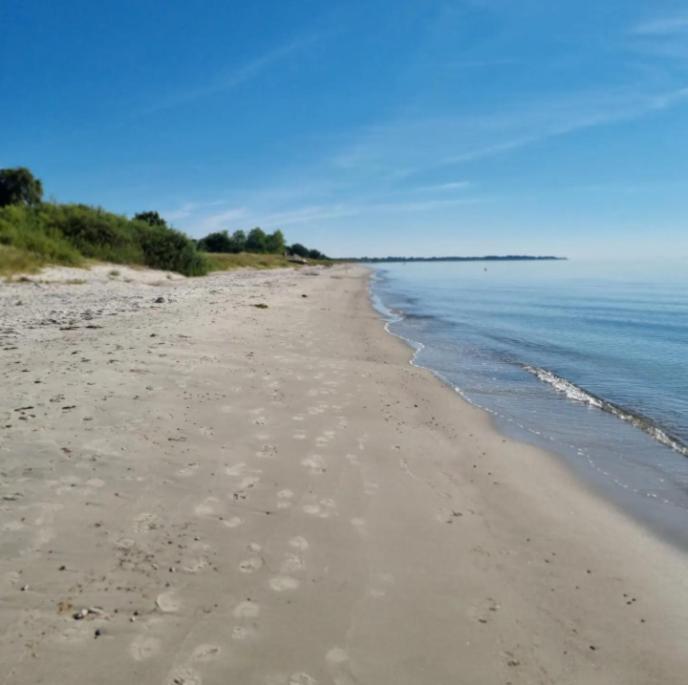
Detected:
[0,0,688,259]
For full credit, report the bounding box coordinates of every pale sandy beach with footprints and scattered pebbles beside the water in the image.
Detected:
[0,265,688,685]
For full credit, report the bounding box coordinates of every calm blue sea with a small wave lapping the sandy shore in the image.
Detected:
[372,261,688,549]
